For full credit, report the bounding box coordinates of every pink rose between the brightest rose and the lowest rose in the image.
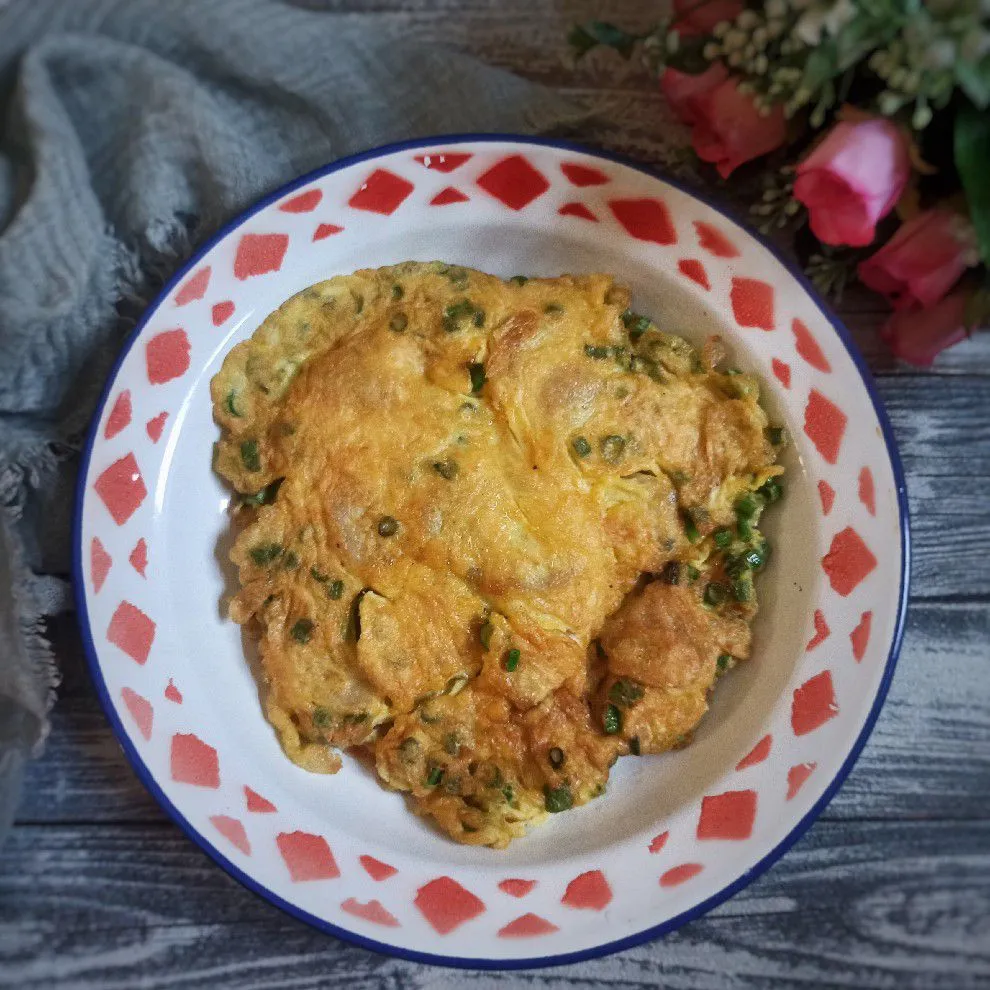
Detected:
[859,210,979,309]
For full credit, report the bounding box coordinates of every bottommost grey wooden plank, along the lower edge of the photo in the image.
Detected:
[0,822,990,990]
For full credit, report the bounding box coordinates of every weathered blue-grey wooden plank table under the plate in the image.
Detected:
[0,0,990,990]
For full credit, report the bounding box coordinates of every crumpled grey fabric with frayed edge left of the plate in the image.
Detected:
[0,0,576,837]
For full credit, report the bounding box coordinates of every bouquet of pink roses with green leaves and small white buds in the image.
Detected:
[569,0,990,365]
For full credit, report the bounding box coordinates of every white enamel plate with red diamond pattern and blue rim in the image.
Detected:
[74,136,908,968]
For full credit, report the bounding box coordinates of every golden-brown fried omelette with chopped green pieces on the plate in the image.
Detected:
[211,262,785,848]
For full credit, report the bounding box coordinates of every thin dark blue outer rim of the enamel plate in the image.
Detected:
[71,132,911,970]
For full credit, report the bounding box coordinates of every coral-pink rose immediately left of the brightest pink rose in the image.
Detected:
[691,78,786,179]
